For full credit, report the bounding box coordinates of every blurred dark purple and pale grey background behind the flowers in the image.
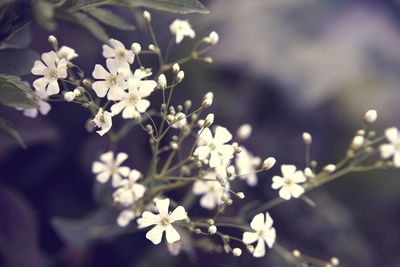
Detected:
[0,0,400,267]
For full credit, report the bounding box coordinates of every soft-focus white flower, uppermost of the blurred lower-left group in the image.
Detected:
[92,151,130,187]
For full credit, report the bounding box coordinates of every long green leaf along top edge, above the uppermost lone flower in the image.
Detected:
[127,0,210,14]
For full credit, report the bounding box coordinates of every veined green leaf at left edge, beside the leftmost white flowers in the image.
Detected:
[0,74,37,109]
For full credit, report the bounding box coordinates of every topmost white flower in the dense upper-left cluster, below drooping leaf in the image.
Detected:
[103,39,135,71]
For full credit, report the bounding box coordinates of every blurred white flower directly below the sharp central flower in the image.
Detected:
[193,169,229,210]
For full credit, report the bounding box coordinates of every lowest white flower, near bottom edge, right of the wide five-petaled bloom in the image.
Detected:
[242,212,276,257]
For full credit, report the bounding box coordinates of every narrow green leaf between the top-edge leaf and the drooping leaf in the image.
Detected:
[84,7,135,30]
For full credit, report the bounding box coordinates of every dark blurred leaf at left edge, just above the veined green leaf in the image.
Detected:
[0,49,39,76]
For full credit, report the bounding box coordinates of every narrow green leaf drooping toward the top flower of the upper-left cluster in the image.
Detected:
[60,12,110,42]
